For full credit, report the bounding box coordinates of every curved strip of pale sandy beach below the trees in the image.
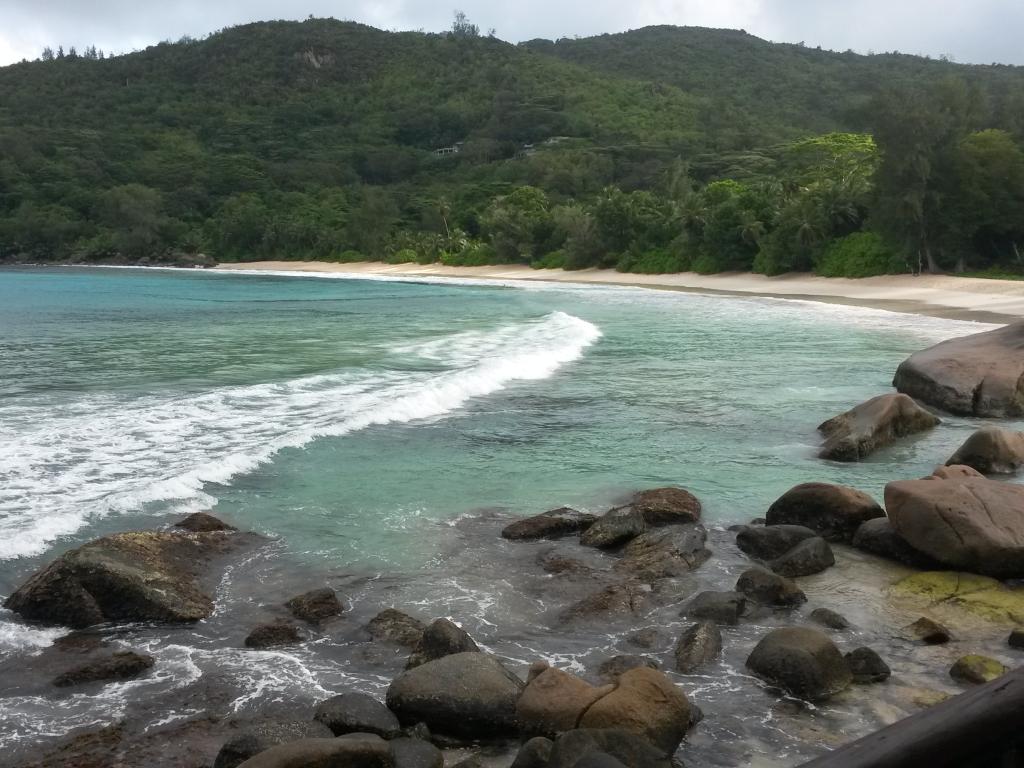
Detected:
[218,261,1024,323]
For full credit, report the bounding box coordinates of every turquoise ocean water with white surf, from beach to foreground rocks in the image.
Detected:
[0,268,1011,765]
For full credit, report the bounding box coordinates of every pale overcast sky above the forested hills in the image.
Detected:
[0,0,1024,65]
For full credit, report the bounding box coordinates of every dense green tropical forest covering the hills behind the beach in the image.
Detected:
[0,15,1024,276]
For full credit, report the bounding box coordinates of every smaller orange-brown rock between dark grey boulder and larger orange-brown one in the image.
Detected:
[516,665,615,736]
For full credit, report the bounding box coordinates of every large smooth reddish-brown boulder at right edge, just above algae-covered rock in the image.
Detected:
[885,477,1024,579]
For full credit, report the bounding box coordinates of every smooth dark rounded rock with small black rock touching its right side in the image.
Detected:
[746,627,853,701]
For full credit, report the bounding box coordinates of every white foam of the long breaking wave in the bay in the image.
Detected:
[0,312,601,559]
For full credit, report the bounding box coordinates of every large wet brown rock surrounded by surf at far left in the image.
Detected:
[4,531,240,629]
